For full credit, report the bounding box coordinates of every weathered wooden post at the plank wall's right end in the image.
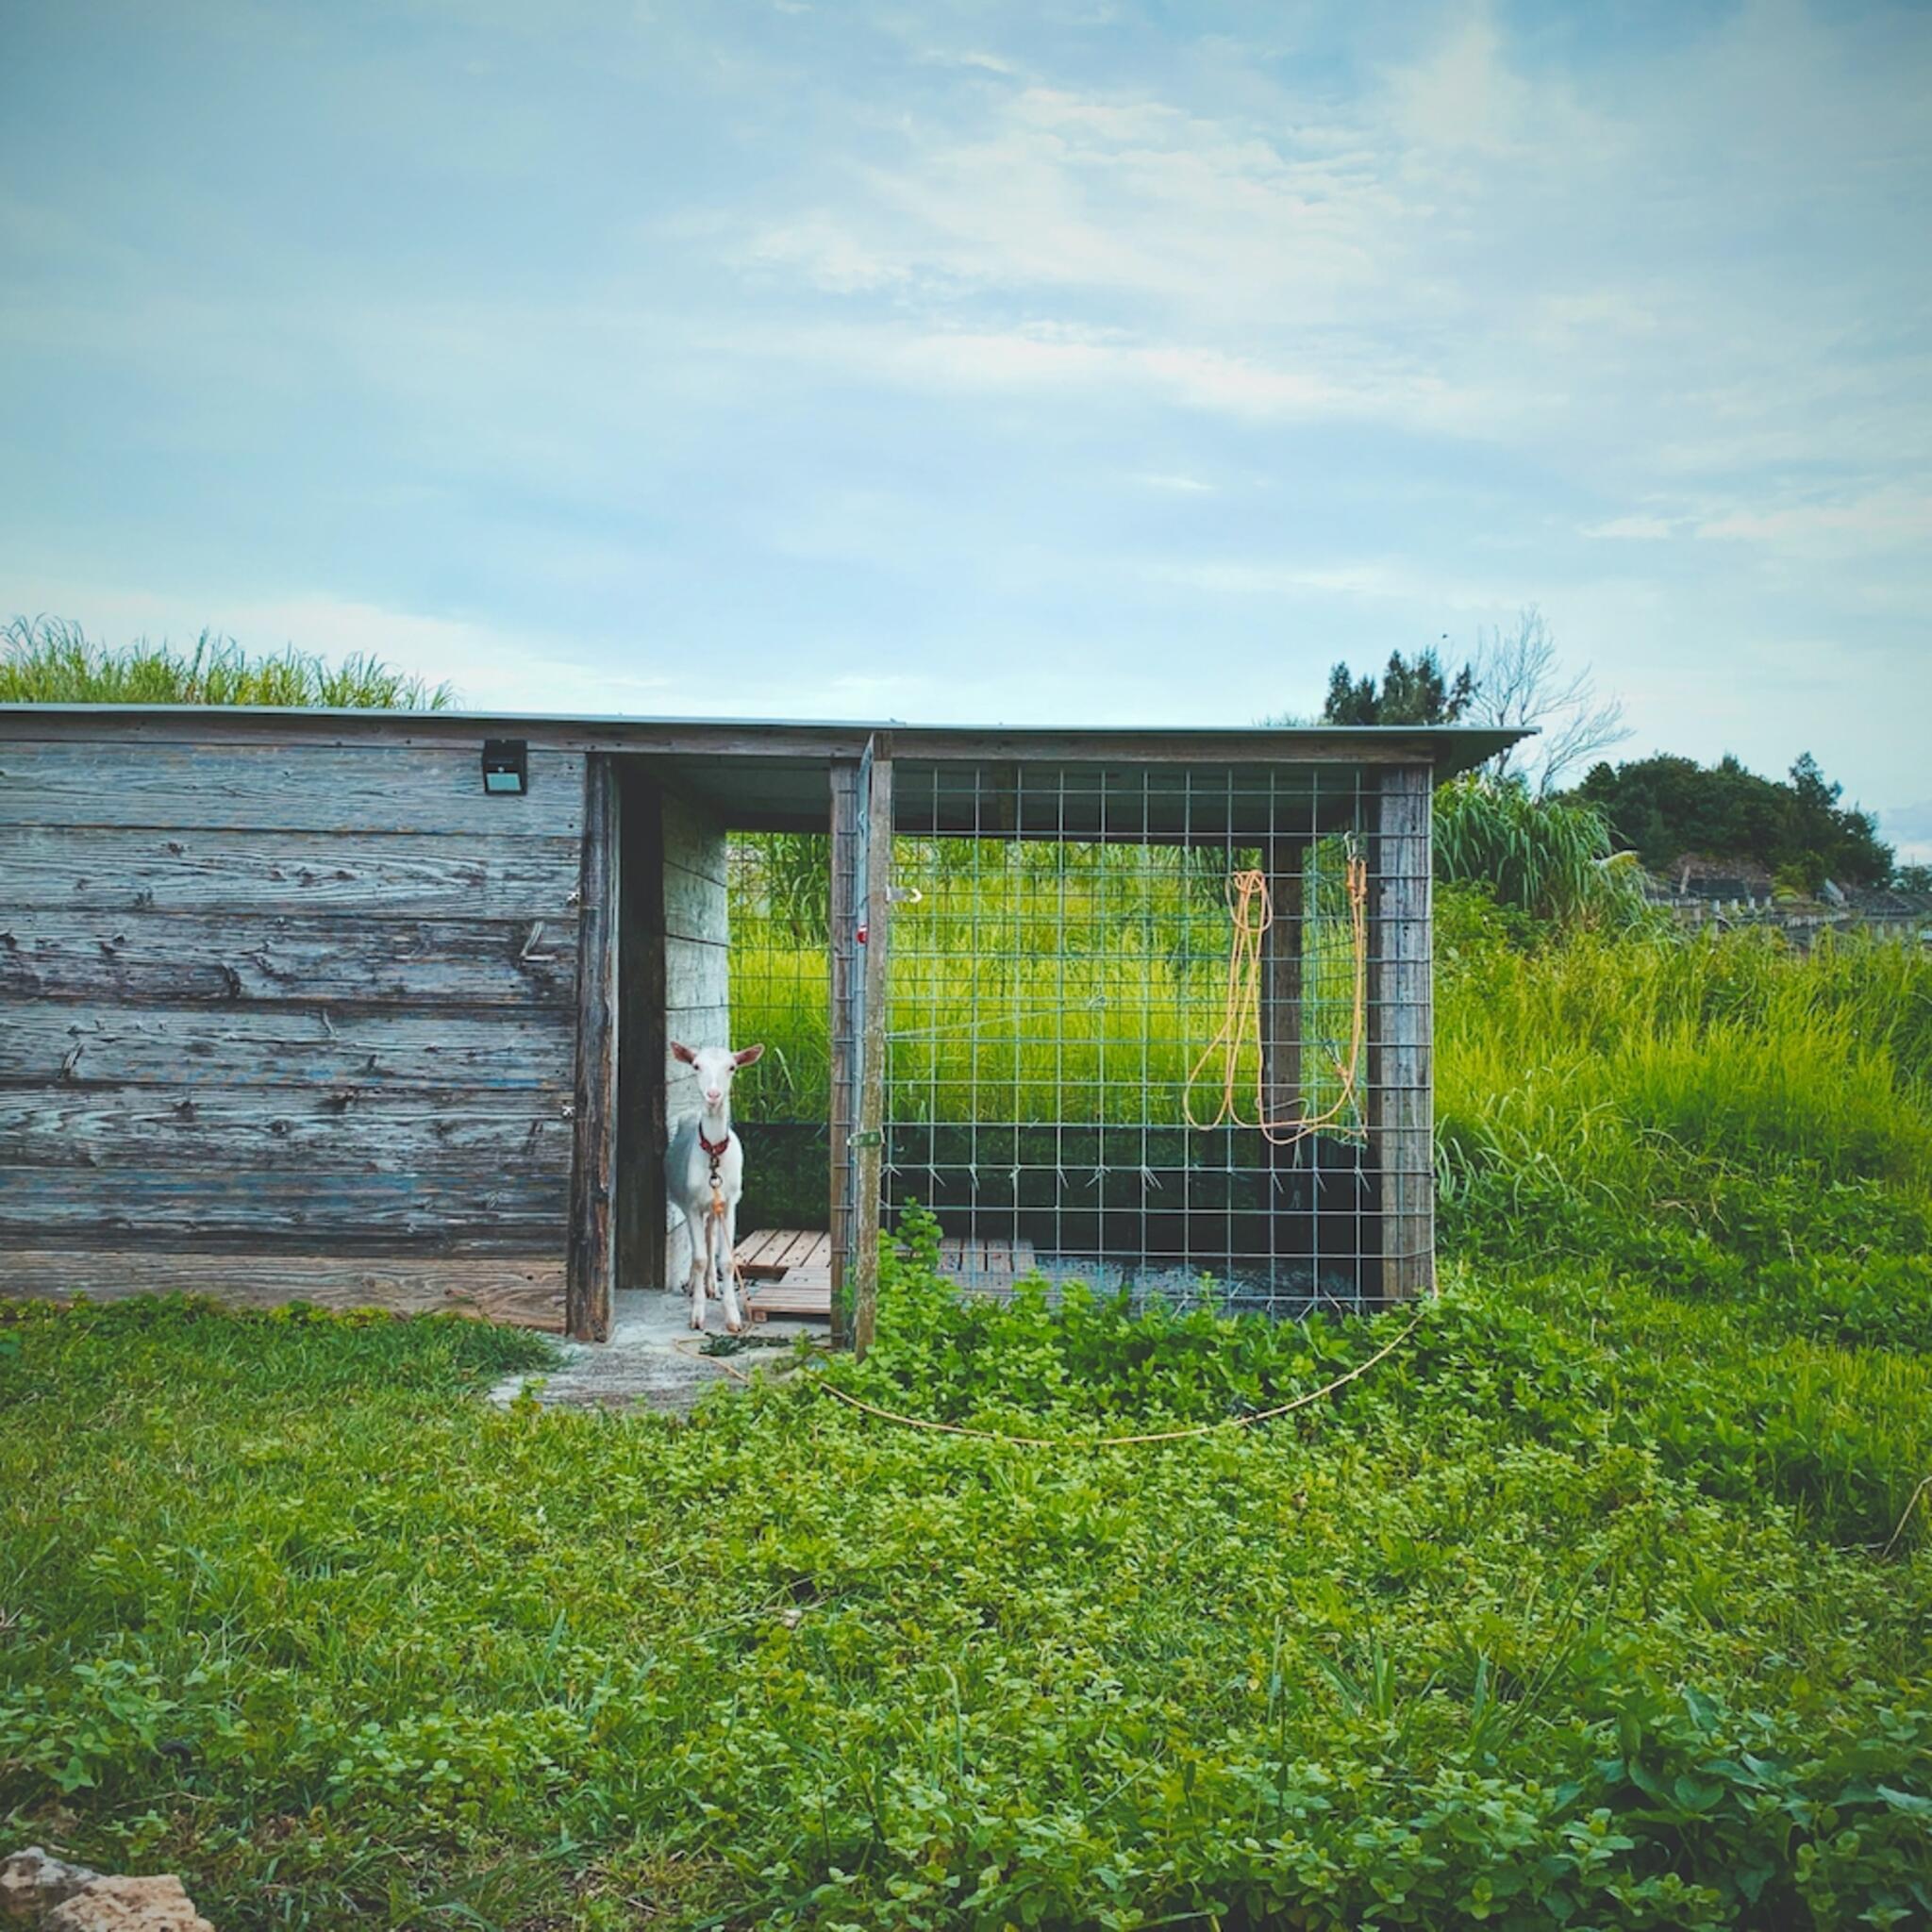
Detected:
[564,752,622,1341]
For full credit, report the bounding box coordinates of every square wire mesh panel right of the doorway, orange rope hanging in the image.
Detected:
[887,763,1406,1312]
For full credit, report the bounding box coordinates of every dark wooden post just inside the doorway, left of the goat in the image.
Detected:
[614,769,665,1289]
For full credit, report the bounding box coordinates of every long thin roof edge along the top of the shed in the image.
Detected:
[0,703,1534,776]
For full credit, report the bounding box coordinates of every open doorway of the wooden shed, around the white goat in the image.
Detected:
[594,754,885,1341]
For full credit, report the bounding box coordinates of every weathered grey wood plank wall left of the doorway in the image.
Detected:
[0,719,586,1327]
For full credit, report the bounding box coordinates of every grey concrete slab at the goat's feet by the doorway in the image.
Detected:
[489,1289,824,1412]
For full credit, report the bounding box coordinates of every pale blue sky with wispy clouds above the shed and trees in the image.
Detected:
[0,0,1932,858]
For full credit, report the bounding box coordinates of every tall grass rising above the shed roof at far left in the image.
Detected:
[0,616,454,711]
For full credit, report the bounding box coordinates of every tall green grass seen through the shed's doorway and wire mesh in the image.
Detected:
[732,837,1357,1126]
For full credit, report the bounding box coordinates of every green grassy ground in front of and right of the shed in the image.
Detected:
[0,907,1932,1932]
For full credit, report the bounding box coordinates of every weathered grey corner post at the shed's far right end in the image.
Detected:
[1368,765,1436,1300]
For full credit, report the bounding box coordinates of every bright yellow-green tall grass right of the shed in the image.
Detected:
[1436,908,1932,1215]
